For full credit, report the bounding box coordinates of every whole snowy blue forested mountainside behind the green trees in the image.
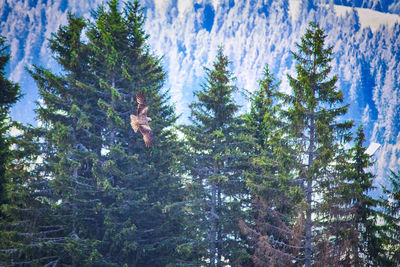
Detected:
[0,0,400,188]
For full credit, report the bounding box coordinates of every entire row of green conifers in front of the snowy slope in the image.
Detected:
[0,0,400,267]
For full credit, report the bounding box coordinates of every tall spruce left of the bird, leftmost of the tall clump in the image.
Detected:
[29,14,109,266]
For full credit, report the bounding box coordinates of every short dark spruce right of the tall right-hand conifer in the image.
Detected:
[321,126,388,266]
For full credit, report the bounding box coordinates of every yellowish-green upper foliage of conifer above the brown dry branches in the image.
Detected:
[246,66,293,205]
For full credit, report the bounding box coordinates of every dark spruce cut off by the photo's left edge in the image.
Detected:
[0,37,56,266]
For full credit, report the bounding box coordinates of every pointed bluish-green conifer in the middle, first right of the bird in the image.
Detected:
[185,47,252,266]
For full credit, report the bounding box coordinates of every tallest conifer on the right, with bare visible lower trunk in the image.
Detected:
[284,23,352,267]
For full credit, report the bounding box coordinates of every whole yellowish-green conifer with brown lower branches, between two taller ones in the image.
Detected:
[242,66,302,266]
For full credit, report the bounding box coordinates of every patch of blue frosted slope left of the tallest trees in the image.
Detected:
[0,0,104,123]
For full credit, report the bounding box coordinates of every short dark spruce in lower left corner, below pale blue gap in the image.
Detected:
[0,123,64,266]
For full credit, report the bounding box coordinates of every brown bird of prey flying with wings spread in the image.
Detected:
[131,92,153,147]
